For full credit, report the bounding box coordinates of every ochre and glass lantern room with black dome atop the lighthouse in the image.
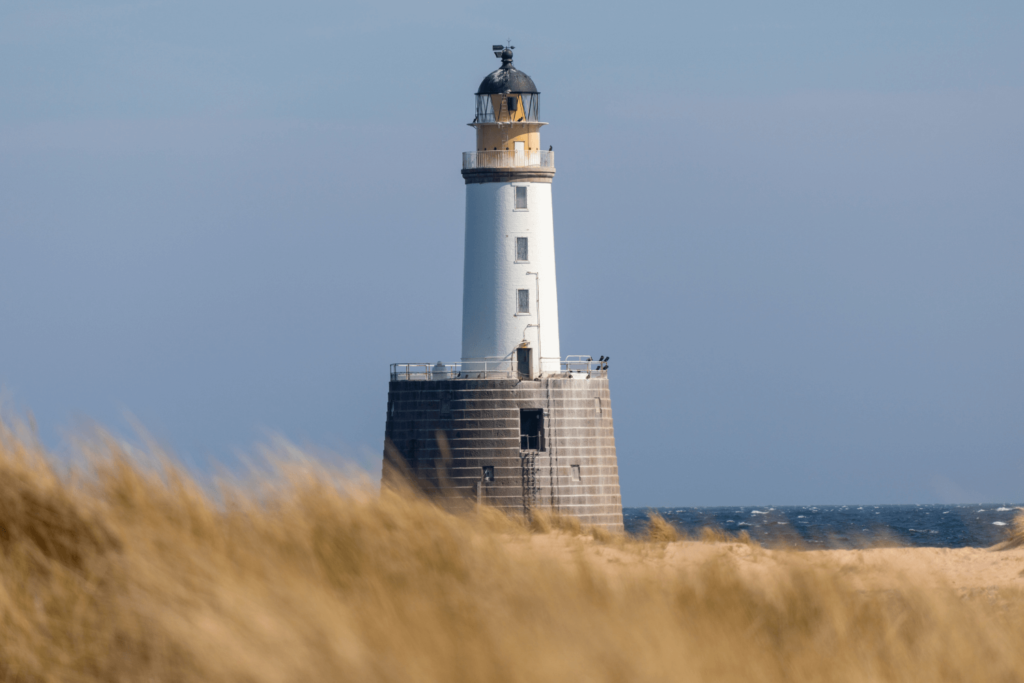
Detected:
[469,45,545,152]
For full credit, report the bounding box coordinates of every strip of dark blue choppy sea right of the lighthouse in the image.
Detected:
[623,503,1020,548]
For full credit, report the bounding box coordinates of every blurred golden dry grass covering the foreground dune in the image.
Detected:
[0,427,1024,683]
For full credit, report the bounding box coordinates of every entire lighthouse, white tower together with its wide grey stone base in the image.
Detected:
[382,45,623,530]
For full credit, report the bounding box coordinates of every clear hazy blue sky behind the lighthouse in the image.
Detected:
[0,0,1024,507]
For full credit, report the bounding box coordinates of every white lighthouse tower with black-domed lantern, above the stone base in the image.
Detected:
[462,45,561,378]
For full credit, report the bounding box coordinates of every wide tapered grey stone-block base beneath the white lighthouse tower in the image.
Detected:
[382,375,623,530]
